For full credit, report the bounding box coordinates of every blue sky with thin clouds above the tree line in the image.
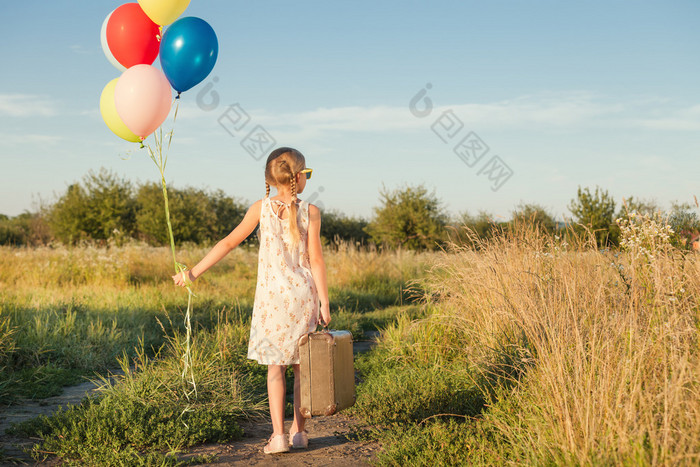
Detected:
[0,0,700,219]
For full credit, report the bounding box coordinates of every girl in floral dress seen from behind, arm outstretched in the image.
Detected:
[173,148,331,454]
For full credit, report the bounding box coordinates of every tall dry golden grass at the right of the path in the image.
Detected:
[427,218,700,465]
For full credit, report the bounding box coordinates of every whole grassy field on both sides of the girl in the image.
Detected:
[0,221,700,465]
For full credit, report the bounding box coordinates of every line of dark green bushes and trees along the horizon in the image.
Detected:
[0,169,700,250]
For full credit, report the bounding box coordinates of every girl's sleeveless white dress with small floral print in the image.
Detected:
[248,197,319,365]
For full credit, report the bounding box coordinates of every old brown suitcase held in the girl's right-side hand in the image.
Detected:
[299,331,355,418]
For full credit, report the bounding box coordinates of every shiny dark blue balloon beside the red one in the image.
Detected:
[160,16,219,94]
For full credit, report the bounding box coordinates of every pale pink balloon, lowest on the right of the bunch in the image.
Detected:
[114,65,173,139]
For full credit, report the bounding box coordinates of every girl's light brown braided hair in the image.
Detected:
[265,148,306,246]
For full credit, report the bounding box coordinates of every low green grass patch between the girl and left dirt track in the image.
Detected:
[14,321,265,465]
